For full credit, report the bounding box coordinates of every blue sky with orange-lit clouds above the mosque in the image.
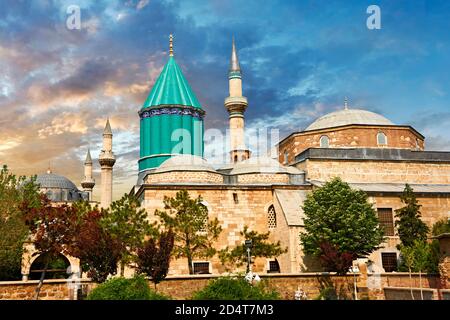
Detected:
[0,0,450,200]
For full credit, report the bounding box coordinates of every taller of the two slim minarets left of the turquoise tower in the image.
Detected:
[98,119,116,208]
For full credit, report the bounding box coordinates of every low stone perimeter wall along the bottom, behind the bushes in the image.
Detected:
[0,273,442,300]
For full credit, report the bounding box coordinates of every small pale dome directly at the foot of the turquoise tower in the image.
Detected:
[155,154,215,173]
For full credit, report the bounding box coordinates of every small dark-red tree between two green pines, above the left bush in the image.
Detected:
[136,230,174,291]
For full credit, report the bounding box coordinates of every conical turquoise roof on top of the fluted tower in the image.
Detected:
[142,56,202,109]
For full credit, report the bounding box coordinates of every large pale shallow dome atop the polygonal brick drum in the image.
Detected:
[305,109,394,131]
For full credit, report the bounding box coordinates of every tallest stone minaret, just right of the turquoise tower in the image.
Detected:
[225,37,250,162]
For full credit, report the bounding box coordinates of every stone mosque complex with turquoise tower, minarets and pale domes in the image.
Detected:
[20,35,450,275]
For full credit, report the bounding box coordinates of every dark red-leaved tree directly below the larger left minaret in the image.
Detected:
[68,205,123,283]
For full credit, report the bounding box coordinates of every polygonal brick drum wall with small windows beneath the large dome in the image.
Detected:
[279,125,425,163]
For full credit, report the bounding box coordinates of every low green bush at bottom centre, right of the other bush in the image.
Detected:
[192,277,280,300]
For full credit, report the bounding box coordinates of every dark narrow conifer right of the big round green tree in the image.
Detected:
[395,184,429,246]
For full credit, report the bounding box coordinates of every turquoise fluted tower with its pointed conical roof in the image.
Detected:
[138,56,205,175]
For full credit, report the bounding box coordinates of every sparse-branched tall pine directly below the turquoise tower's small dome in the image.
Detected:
[155,190,222,274]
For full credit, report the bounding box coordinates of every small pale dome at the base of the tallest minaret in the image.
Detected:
[230,156,301,174]
